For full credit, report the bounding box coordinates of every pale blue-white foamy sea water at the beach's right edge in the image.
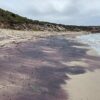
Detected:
[76,33,100,55]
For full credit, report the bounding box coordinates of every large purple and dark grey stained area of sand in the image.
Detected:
[0,36,100,100]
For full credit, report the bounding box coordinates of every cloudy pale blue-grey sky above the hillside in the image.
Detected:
[0,0,100,25]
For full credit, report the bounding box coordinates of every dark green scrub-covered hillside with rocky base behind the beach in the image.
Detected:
[0,9,100,32]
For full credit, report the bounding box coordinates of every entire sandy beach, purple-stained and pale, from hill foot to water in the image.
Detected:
[0,28,100,100]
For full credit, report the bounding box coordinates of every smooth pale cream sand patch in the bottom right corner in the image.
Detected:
[62,70,100,100]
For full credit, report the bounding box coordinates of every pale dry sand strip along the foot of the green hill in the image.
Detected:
[0,29,87,46]
